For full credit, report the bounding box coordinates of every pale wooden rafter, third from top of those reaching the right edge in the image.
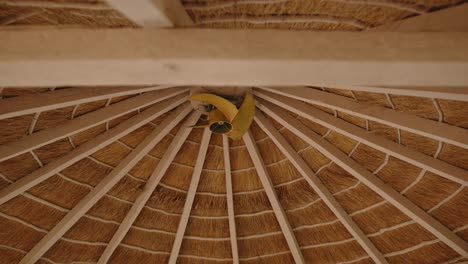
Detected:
[255,91,468,186]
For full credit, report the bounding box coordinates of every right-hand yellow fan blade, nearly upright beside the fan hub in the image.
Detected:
[227,92,255,140]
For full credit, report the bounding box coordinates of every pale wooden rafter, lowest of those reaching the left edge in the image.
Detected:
[0,99,191,205]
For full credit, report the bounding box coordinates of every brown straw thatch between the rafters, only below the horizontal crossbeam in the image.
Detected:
[0,85,468,263]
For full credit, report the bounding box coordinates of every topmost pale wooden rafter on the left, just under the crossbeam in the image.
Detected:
[0,85,181,119]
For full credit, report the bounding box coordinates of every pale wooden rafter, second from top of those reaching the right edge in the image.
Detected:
[261,87,468,148]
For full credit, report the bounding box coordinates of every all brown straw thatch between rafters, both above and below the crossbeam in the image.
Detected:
[0,0,468,264]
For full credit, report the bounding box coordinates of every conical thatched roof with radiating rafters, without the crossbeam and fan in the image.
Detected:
[0,0,468,264]
